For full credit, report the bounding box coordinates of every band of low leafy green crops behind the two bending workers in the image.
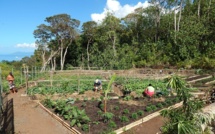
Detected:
[28,74,167,95]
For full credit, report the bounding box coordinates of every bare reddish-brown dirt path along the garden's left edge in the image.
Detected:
[5,89,71,134]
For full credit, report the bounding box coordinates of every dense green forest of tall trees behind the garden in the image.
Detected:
[1,0,215,69]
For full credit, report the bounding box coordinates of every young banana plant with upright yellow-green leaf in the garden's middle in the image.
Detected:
[104,74,116,113]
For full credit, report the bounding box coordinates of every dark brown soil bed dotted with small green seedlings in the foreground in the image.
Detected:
[41,97,179,134]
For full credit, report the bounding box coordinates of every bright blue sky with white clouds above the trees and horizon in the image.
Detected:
[0,0,148,60]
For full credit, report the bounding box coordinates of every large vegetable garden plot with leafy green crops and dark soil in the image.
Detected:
[23,68,190,134]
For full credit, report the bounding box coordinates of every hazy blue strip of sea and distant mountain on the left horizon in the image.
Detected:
[0,52,34,62]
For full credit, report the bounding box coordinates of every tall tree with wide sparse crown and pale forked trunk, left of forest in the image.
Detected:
[45,14,80,70]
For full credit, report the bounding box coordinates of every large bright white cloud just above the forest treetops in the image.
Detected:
[91,0,149,22]
